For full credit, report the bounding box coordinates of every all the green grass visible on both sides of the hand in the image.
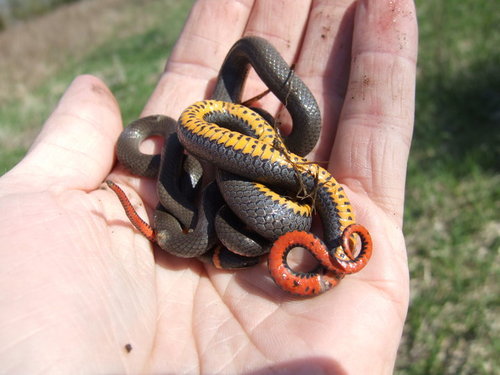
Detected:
[0,0,500,374]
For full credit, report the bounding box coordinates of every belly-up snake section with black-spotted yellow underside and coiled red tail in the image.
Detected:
[177,100,372,295]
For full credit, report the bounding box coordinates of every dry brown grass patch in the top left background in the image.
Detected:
[0,0,176,103]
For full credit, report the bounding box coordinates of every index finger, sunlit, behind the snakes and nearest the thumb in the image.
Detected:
[144,0,253,118]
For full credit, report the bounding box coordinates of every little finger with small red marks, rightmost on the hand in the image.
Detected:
[330,0,417,222]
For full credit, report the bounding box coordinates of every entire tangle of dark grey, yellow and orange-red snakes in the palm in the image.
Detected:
[108,37,372,296]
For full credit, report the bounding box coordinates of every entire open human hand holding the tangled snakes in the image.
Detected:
[0,0,417,374]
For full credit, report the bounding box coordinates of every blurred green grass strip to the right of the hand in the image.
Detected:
[396,0,500,374]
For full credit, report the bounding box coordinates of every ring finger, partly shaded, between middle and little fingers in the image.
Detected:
[296,0,355,161]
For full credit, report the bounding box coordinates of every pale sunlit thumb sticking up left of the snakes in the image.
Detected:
[9,75,122,191]
